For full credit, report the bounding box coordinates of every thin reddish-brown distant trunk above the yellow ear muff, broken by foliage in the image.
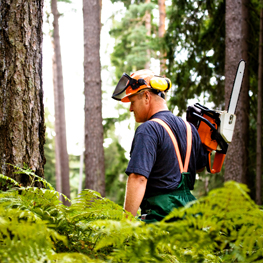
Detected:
[158,0,167,75]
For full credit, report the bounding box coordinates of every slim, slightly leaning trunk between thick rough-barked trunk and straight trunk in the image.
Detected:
[51,0,70,205]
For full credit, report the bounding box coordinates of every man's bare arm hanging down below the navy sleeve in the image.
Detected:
[124,173,147,216]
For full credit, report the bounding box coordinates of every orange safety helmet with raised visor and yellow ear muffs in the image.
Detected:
[112,69,171,102]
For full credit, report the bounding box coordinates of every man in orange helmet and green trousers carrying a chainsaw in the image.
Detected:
[112,70,206,223]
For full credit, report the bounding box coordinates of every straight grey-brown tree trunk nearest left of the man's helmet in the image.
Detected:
[83,0,105,196]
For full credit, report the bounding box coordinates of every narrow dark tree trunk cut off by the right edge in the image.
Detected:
[256,5,263,205]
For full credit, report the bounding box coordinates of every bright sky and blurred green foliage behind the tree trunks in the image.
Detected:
[43,0,260,204]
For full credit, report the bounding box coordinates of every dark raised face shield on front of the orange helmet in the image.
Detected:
[112,73,147,102]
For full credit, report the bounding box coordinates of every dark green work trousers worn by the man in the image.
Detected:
[140,173,196,223]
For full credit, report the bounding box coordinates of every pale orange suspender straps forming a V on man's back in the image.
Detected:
[151,118,192,173]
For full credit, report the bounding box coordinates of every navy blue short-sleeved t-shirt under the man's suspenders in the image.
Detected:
[126,111,207,195]
